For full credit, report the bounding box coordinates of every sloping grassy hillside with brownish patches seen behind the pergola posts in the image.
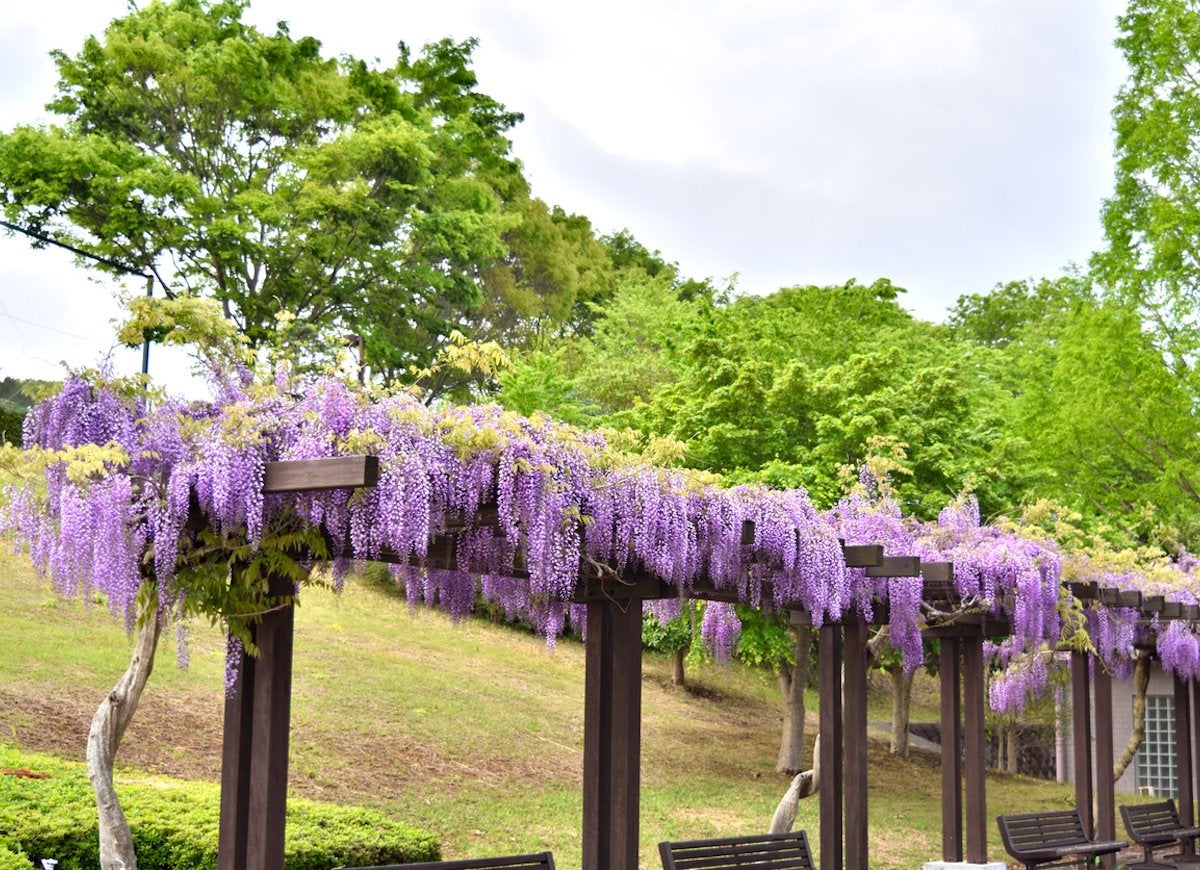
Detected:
[0,553,1108,870]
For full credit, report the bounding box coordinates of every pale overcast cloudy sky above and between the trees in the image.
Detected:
[0,0,1124,393]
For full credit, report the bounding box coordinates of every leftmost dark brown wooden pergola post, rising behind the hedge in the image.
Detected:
[217,577,295,870]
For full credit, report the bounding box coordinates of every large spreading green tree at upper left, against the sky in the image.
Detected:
[0,0,520,391]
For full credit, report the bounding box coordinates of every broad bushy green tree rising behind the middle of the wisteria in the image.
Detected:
[636,281,1009,516]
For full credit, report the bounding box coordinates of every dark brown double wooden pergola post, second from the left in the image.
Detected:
[583,598,642,870]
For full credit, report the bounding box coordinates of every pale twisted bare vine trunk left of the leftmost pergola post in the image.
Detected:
[88,595,162,870]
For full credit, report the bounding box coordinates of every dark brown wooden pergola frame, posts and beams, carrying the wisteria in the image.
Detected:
[218,457,1161,870]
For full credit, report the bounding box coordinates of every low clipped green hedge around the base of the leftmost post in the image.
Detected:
[0,746,440,870]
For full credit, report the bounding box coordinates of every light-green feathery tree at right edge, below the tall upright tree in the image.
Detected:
[1014,302,1200,546]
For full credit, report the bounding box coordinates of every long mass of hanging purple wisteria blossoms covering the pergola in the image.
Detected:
[7,372,1200,712]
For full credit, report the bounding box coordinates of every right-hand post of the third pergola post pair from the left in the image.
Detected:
[840,622,869,870]
